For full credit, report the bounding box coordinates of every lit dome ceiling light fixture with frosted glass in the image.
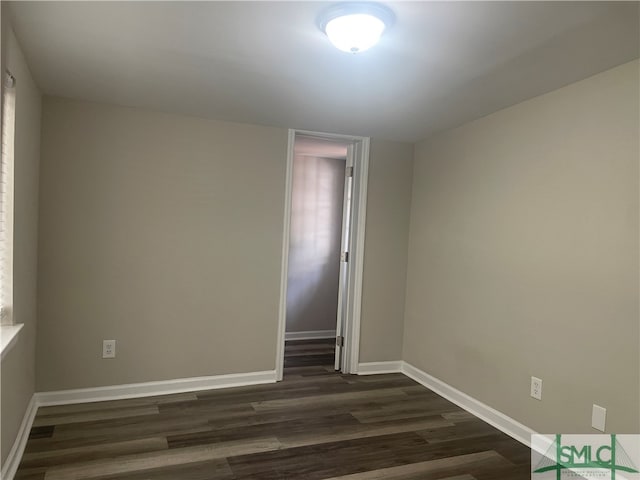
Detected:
[319,2,395,53]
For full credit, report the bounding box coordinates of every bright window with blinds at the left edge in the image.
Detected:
[0,72,16,325]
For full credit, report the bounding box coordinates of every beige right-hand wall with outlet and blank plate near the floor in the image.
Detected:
[404,61,640,433]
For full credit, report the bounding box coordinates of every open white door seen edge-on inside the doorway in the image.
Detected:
[335,145,354,370]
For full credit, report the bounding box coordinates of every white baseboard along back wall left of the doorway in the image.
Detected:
[36,370,276,406]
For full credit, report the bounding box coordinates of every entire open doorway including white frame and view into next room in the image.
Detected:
[276,130,369,380]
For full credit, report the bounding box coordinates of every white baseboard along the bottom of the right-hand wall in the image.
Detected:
[402,362,537,448]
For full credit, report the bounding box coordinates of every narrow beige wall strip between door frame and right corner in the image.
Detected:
[360,139,413,362]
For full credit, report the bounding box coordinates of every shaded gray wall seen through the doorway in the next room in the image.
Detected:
[286,155,346,332]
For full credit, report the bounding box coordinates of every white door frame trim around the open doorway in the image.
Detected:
[276,128,370,381]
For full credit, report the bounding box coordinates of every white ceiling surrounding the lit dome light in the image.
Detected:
[6,1,639,141]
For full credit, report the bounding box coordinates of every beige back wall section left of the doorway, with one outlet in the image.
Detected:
[37,97,287,391]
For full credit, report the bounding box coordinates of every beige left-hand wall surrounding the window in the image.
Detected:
[0,22,41,462]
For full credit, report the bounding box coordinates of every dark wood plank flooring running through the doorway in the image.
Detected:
[16,341,531,480]
